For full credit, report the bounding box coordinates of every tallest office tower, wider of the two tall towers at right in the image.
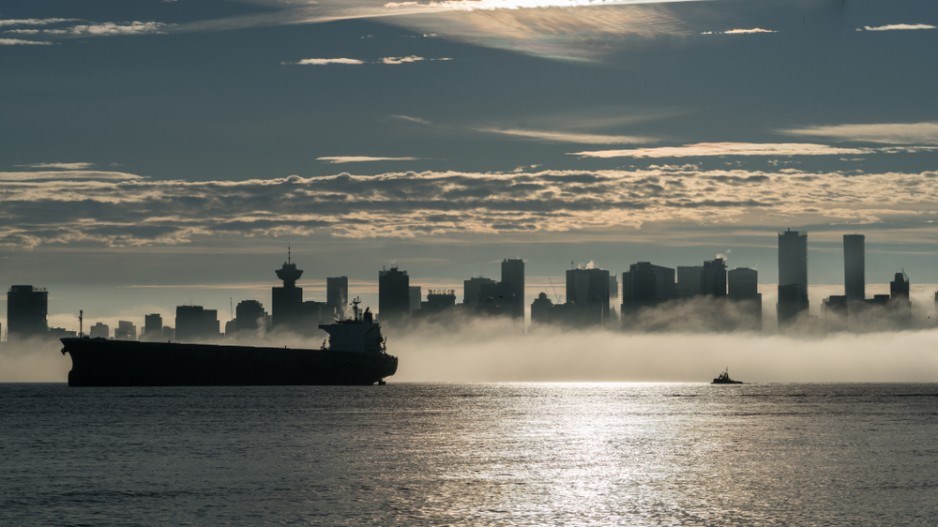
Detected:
[777,229,808,327]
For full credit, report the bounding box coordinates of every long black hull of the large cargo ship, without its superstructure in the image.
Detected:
[62,338,397,386]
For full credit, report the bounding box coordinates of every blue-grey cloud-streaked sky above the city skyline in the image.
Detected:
[0,0,938,325]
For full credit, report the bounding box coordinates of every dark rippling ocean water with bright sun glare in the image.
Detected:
[0,382,938,526]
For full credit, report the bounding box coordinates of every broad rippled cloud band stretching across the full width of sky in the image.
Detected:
[0,165,938,247]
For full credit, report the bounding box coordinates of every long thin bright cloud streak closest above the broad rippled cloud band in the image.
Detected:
[570,142,877,159]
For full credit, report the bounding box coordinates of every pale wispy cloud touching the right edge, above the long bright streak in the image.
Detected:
[780,122,938,145]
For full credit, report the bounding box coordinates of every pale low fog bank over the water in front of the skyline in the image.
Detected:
[0,302,938,382]
